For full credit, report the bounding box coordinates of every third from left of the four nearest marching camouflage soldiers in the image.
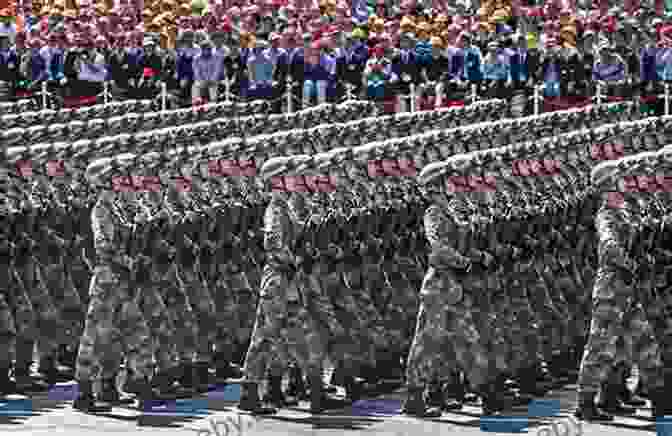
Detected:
[403,162,500,417]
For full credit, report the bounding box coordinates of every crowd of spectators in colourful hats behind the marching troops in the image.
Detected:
[0,0,672,111]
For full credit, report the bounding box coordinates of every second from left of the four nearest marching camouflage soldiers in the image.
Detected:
[238,159,338,414]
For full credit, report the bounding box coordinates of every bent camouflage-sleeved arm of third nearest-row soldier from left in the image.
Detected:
[424,206,471,269]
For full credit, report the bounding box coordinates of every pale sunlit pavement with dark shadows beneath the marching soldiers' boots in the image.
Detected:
[0,386,663,436]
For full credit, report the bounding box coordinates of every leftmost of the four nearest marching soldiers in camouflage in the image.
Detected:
[74,158,152,413]
